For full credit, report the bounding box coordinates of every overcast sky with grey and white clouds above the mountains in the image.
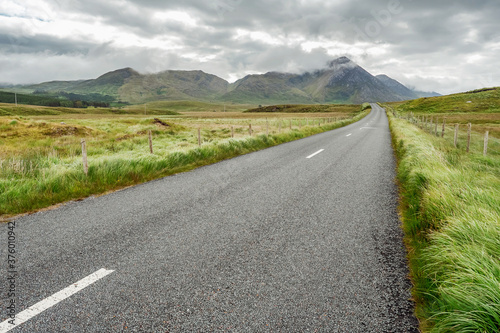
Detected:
[0,0,500,93]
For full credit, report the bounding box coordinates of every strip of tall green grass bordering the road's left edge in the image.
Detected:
[0,111,369,217]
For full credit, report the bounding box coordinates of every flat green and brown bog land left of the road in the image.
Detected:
[0,101,369,218]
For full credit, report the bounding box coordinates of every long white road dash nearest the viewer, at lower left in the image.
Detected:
[0,268,114,333]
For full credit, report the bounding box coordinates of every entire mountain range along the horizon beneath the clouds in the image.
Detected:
[16,57,439,104]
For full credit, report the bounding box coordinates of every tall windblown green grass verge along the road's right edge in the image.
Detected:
[389,108,500,333]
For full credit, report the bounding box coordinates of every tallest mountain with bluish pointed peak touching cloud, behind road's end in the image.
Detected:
[223,57,418,104]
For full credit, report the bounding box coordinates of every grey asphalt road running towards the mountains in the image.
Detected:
[0,105,418,333]
